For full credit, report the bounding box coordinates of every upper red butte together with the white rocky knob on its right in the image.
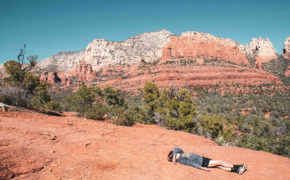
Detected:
[162,31,280,69]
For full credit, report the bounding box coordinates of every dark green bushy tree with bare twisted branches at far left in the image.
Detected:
[0,45,60,112]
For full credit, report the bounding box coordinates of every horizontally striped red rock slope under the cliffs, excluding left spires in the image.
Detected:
[92,65,281,91]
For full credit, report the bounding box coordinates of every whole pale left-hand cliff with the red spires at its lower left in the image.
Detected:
[36,30,172,84]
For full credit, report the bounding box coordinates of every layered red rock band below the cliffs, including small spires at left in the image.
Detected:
[44,61,281,93]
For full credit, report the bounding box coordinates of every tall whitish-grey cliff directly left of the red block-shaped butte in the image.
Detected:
[80,30,171,68]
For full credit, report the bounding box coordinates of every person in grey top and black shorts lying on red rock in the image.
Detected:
[167,147,248,175]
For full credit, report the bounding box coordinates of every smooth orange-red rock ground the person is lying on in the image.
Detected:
[0,112,290,180]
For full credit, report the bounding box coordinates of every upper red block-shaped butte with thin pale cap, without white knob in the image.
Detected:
[161,32,249,64]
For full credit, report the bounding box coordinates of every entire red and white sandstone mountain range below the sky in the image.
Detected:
[30,30,289,90]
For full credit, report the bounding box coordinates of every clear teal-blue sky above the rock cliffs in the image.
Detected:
[0,0,290,64]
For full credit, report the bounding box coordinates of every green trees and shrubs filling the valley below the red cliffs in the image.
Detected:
[57,83,290,156]
